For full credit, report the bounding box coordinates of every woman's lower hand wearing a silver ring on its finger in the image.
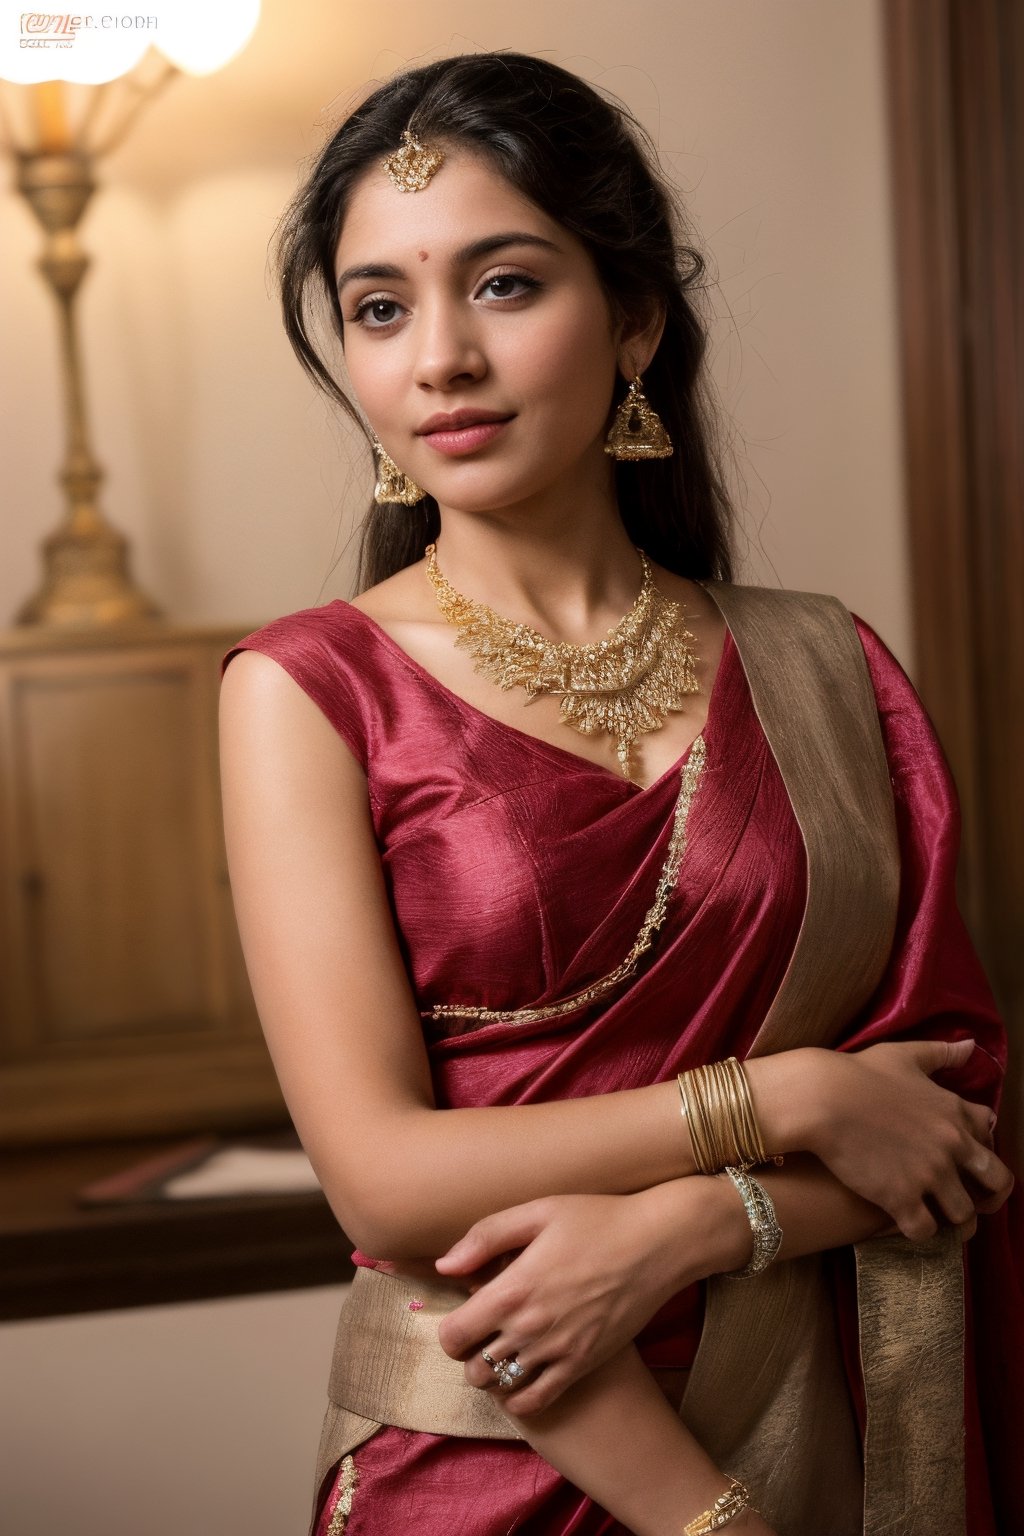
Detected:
[438,1177,736,1416]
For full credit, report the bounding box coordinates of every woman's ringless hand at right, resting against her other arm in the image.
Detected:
[808,1040,1013,1241]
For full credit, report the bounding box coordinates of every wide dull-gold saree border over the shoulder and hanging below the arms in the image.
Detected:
[682,582,966,1536]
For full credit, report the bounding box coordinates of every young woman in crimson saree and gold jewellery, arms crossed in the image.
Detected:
[223,54,1016,1536]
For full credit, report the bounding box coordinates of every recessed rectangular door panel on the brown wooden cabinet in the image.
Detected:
[14,664,212,1044]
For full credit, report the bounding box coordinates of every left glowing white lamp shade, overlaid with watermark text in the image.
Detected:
[0,0,157,86]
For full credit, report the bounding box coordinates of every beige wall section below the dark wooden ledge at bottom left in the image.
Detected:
[0,1286,348,1536]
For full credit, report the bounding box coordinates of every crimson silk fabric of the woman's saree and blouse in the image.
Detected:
[226,580,1021,1536]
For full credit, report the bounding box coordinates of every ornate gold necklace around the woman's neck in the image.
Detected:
[427,544,700,779]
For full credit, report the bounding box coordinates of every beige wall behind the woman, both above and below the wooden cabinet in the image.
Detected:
[0,0,909,1536]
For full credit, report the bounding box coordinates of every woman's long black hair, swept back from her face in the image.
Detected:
[276,52,731,590]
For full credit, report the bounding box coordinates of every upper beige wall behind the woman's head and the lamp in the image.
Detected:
[0,0,909,656]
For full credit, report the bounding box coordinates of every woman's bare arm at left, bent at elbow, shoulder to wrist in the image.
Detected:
[221,651,1007,1260]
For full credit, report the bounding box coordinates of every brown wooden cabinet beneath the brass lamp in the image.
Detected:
[0,625,286,1144]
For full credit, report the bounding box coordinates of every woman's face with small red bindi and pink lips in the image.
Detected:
[335,151,619,510]
